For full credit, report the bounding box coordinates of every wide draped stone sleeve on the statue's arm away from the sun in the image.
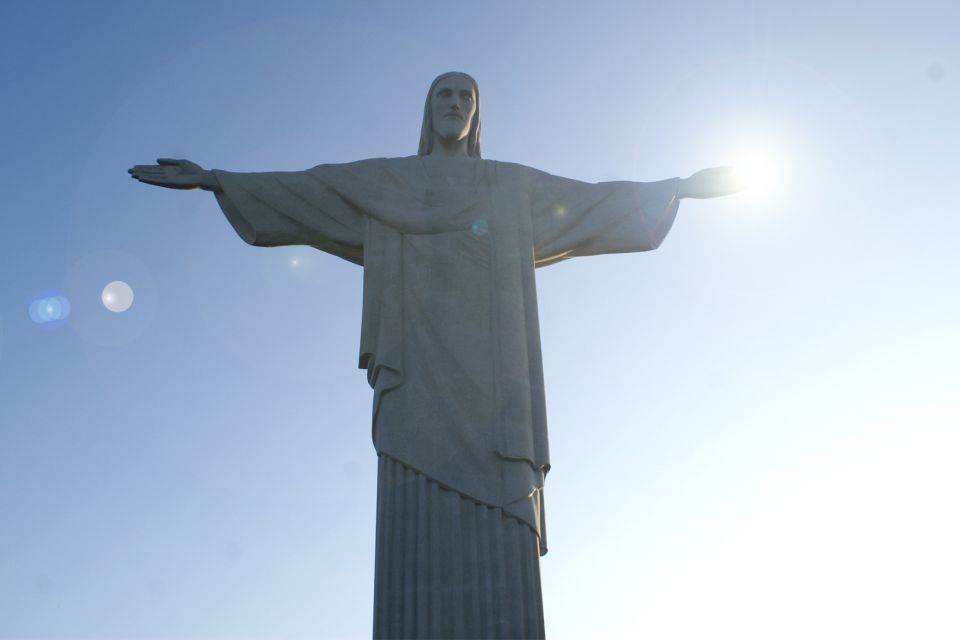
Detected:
[213,163,369,265]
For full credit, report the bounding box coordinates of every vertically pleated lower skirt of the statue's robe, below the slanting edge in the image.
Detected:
[373,453,544,638]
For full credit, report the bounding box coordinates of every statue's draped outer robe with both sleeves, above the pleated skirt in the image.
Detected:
[214,156,679,554]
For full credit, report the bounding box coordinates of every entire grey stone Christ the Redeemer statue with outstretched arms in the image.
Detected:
[130,73,737,638]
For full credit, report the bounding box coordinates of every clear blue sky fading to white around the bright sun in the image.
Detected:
[0,0,960,640]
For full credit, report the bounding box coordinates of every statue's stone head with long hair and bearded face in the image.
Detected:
[417,71,480,158]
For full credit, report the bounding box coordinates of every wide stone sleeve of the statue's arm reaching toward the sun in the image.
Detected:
[531,172,680,267]
